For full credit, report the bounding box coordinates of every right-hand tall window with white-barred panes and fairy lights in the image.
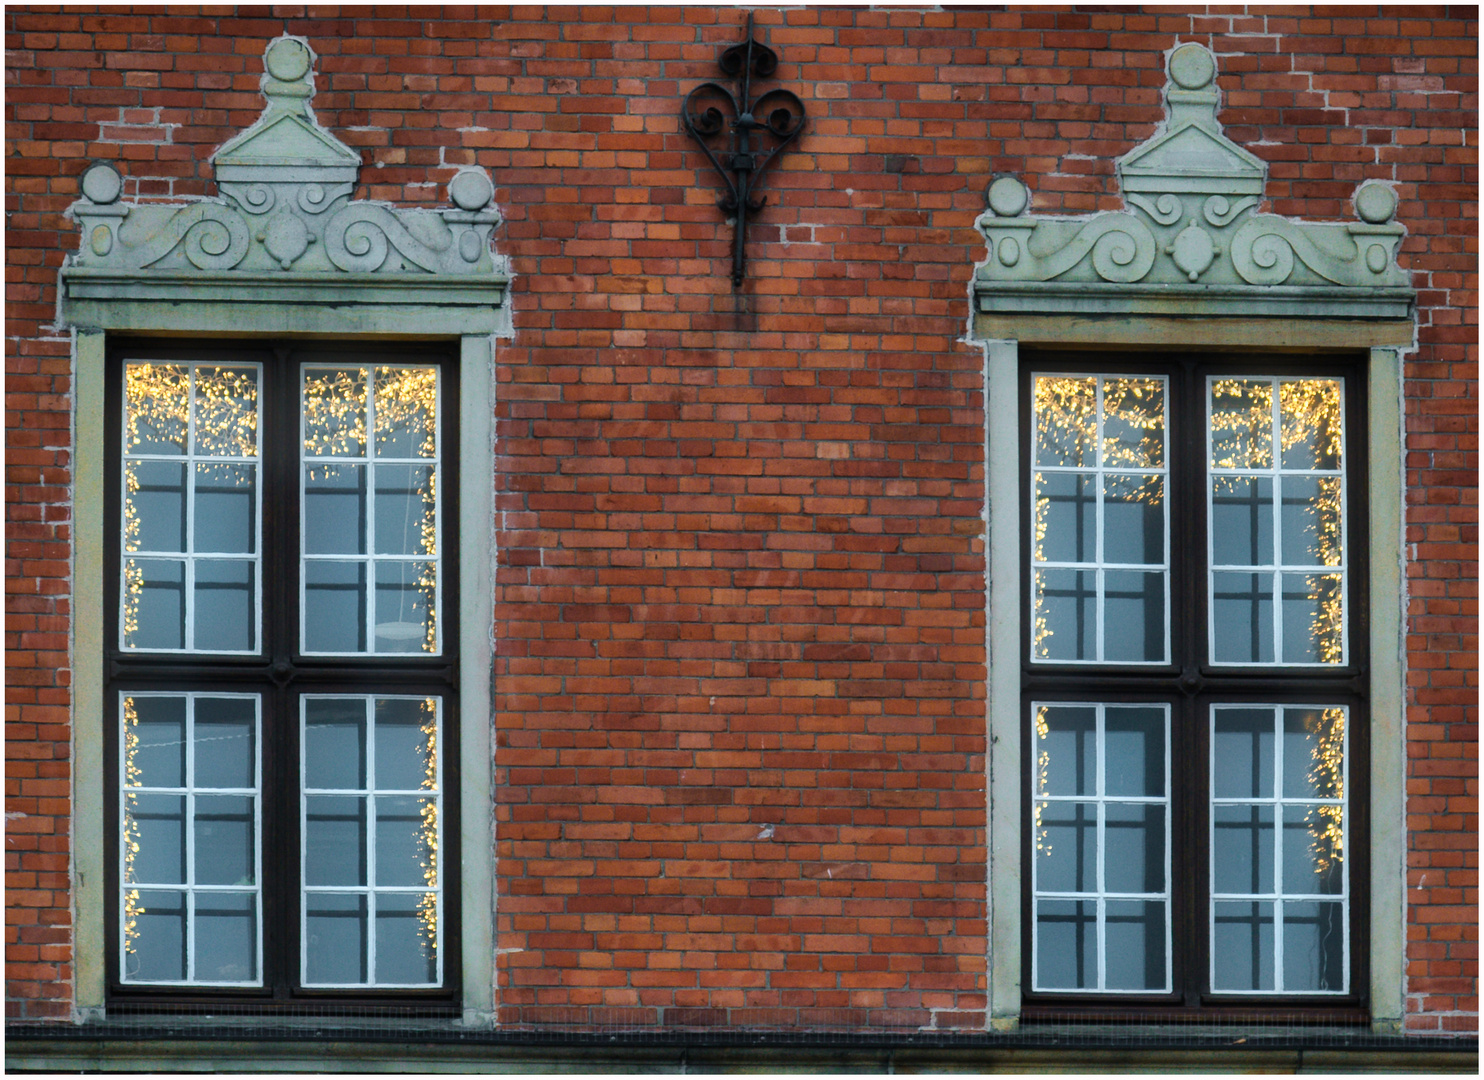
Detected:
[1022,356,1365,1009]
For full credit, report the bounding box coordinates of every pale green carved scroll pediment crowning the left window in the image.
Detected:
[62,37,500,292]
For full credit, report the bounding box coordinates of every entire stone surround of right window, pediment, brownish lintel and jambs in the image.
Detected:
[969,43,1416,1033]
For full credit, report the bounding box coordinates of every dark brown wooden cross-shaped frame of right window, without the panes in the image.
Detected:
[1017,347,1370,1024]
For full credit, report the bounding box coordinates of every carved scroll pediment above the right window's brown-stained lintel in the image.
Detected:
[975,45,1413,317]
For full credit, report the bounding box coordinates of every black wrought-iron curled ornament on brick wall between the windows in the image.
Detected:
[681,13,806,288]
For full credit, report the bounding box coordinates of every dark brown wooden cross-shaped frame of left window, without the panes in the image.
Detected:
[101,337,462,1016]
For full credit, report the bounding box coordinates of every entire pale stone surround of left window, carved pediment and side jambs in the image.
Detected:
[58,36,510,1025]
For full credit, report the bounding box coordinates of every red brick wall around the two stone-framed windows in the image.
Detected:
[4,7,1478,1031]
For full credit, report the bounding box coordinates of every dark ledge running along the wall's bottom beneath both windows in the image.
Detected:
[6,1015,1478,1073]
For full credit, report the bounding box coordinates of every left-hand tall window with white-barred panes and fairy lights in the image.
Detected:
[105,343,457,1000]
